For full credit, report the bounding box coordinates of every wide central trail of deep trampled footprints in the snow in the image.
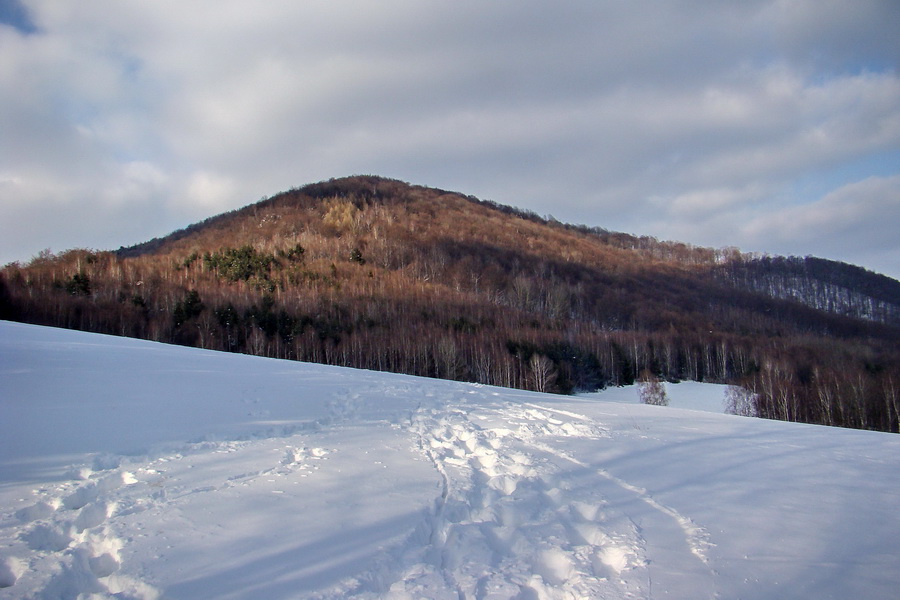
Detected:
[402,394,647,599]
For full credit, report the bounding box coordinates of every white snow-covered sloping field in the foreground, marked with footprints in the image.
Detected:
[0,323,900,600]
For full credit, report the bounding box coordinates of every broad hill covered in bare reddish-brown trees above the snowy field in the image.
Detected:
[0,176,900,431]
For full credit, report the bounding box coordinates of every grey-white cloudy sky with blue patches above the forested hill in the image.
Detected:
[0,0,900,278]
